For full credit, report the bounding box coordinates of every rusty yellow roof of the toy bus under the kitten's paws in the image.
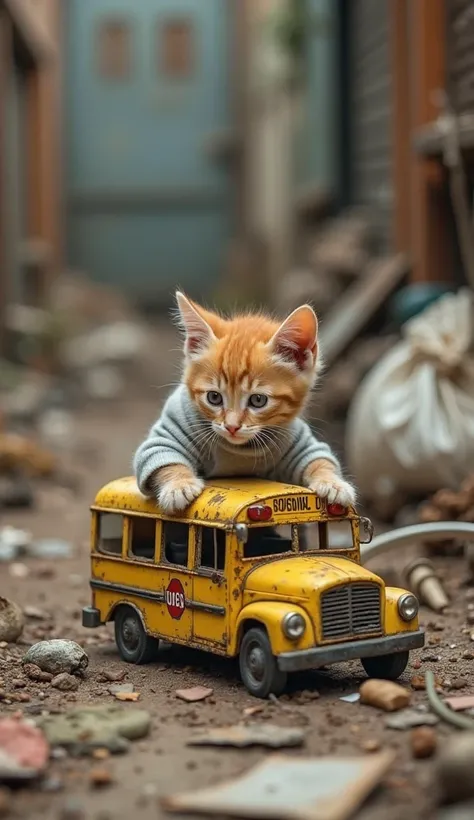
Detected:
[93,476,318,524]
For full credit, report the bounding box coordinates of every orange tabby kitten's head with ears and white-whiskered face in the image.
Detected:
[176,293,318,447]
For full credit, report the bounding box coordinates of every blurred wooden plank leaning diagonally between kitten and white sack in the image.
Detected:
[320,254,409,365]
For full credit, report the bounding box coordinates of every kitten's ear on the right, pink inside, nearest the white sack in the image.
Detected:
[269,305,318,371]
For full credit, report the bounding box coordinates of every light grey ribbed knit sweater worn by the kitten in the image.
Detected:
[133,385,339,495]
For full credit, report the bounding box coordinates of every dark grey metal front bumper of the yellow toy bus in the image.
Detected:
[277,629,425,672]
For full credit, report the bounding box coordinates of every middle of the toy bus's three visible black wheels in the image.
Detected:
[239,627,288,698]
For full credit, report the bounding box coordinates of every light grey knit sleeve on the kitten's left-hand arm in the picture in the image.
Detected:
[133,395,200,495]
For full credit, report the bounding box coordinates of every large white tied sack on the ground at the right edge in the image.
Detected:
[346,290,474,497]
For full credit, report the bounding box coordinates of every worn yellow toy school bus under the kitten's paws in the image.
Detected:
[82,478,424,698]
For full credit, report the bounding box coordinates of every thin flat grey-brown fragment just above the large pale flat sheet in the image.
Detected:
[187,723,305,749]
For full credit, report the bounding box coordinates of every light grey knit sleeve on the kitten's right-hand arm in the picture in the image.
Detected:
[276,419,341,484]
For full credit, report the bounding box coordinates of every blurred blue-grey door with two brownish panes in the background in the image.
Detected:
[65,0,233,303]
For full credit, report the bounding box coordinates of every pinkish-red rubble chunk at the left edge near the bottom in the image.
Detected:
[0,718,49,782]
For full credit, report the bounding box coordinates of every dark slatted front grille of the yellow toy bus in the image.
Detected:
[321,584,382,641]
